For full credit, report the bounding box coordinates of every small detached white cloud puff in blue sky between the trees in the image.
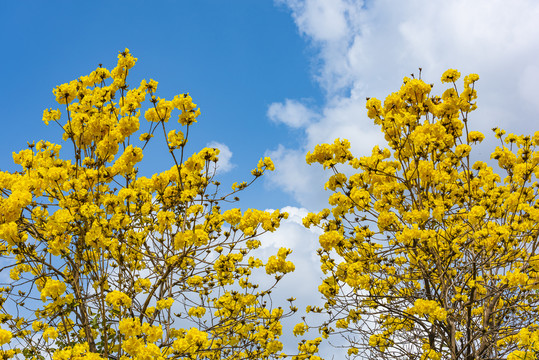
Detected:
[267,99,317,128]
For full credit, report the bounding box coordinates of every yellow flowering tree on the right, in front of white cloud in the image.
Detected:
[306,70,539,360]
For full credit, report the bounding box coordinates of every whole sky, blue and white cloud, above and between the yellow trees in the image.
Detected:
[0,0,539,358]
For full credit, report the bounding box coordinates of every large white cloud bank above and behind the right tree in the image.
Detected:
[268,0,539,209]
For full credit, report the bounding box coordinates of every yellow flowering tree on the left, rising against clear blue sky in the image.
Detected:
[0,49,295,360]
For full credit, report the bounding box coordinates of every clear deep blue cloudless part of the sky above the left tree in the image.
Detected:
[0,0,321,207]
